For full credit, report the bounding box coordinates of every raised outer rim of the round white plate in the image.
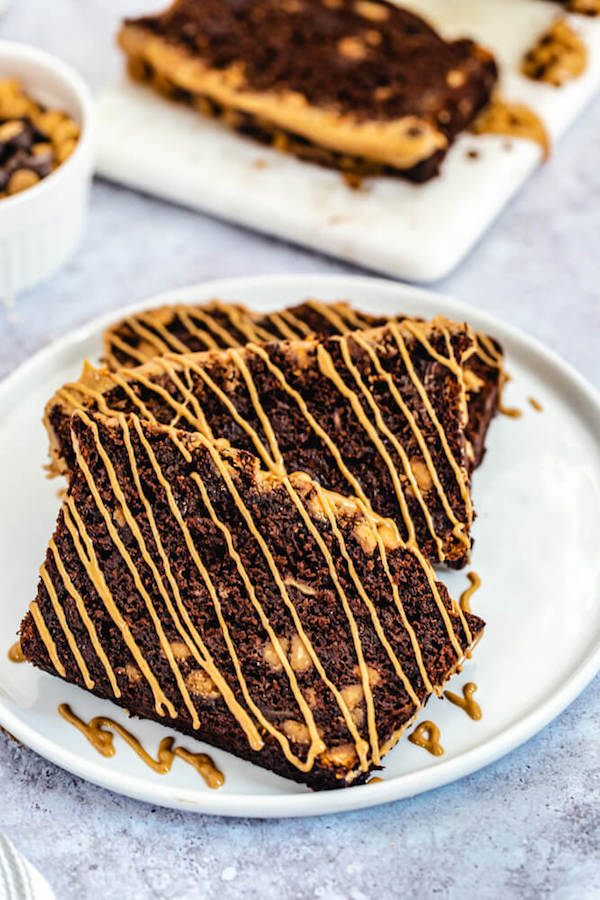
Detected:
[0,273,600,818]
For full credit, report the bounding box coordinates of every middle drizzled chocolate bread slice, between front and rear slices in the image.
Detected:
[46,317,473,567]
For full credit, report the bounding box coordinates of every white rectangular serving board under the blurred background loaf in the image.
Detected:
[98,0,600,281]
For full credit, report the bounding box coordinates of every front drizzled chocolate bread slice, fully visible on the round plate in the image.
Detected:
[21,412,484,789]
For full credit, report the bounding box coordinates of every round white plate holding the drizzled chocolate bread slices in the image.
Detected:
[0,276,600,816]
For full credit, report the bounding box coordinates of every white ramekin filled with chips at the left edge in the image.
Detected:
[0,41,94,303]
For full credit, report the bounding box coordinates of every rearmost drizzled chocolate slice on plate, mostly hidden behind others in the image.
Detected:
[103,300,503,468]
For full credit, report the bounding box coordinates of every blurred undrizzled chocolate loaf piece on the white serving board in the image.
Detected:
[119,0,497,181]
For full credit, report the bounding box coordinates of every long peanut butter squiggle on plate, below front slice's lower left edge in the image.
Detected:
[58,703,225,788]
